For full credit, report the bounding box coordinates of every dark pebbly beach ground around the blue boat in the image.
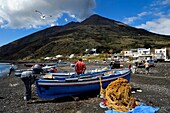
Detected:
[0,63,170,113]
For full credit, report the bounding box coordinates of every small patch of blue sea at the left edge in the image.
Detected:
[0,63,11,78]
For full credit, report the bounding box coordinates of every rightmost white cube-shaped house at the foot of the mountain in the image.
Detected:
[155,48,167,60]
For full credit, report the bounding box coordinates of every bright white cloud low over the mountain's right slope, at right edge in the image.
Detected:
[137,18,170,35]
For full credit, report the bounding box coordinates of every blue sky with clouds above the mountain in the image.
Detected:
[0,0,170,46]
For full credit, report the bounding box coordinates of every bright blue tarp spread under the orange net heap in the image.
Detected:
[105,102,159,113]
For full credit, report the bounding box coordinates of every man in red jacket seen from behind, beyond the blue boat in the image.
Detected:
[75,58,86,74]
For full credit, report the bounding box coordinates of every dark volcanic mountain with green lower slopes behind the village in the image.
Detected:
[0,15,170,60]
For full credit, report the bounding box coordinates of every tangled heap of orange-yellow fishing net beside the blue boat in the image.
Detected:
[100,78,139,112]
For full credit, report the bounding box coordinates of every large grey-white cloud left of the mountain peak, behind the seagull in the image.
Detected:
[0,0,96,28]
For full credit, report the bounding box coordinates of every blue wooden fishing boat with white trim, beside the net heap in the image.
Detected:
[35,69,131,98]
